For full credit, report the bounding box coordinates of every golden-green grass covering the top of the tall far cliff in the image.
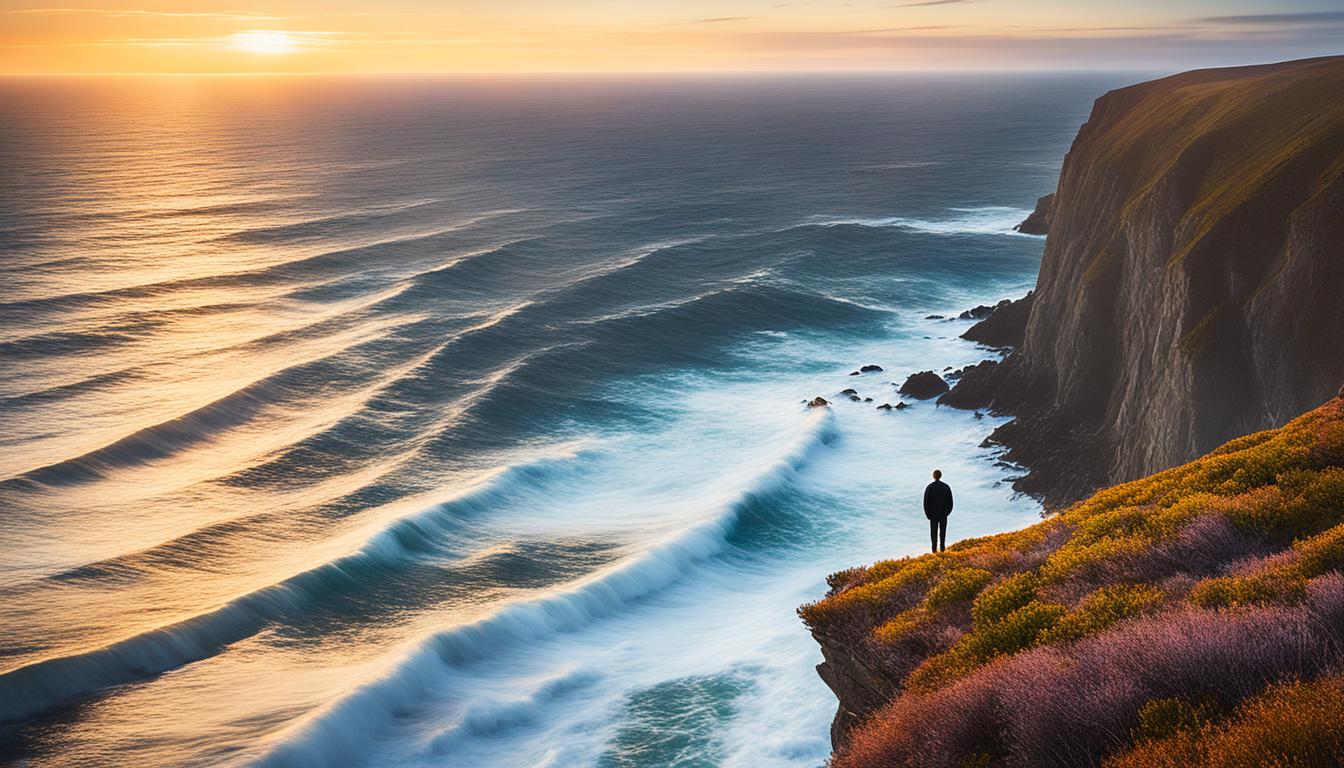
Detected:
[1056,56,1344,279]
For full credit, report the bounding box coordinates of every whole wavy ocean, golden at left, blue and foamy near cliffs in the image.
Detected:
[0,74,1144,768]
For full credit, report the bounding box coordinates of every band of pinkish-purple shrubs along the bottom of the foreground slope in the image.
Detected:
[835,604,1344,768]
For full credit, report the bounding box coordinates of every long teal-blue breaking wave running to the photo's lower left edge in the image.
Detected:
[0,451,585,722]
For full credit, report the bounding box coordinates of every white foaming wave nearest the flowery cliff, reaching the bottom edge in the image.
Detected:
[258,410,836,767]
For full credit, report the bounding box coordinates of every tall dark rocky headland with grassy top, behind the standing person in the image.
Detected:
[954,56,1344,504]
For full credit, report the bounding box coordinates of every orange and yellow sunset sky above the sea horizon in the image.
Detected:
[0,0,1344,75]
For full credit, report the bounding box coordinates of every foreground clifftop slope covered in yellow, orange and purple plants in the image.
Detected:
[800,398,1344,768]
